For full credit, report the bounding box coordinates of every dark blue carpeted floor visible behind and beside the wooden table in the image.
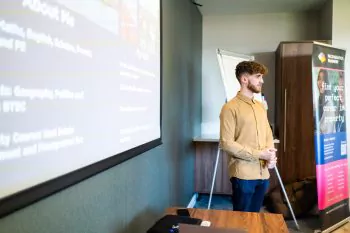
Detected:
[195,195,318,233]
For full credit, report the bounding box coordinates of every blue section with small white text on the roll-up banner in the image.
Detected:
[315,132,347,165]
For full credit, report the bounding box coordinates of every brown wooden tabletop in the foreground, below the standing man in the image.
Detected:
[166,207,289,233]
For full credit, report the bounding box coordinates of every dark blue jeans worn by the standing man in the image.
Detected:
[230,177,269,212]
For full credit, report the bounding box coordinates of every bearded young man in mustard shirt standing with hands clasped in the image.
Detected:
[220,61,277,212]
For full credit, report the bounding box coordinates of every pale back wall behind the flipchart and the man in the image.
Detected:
[202,11,322,134]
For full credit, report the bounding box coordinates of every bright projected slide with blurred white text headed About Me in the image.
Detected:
[0,0,160,199]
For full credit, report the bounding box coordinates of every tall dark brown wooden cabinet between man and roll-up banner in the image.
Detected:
[275,42,330,183]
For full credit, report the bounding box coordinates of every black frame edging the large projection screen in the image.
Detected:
[0,0,163,218]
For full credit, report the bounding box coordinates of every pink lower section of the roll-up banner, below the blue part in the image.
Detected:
[316,159,349,210]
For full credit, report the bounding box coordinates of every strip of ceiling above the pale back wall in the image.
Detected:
[194,0,326,16]
